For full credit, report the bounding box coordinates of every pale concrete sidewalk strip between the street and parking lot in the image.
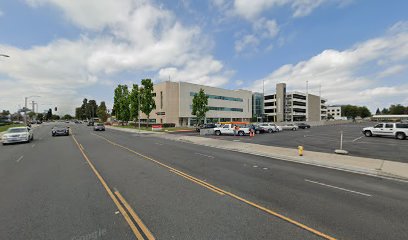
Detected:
[107,128,408,180]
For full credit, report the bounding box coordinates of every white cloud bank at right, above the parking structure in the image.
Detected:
[251,23,408,107]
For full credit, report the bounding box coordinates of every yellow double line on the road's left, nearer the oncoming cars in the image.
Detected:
[71,134,155,240]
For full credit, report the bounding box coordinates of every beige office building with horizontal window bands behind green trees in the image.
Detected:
[141,81,252,126]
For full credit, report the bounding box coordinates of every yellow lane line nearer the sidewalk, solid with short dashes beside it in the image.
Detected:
[92,133,336,240]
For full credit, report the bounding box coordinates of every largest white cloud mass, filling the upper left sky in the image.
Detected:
[0,0,229,112]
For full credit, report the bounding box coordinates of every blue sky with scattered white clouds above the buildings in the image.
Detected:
[0,0,408,115]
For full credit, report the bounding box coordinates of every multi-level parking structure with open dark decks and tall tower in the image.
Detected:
[264,83,327,122]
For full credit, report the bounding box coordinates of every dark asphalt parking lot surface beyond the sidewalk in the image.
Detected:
[171,122,408,162]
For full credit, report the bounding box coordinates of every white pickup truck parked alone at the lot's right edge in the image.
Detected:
[363,123,408,140]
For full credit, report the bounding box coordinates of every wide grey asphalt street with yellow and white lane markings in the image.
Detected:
[0,125,408,239]
